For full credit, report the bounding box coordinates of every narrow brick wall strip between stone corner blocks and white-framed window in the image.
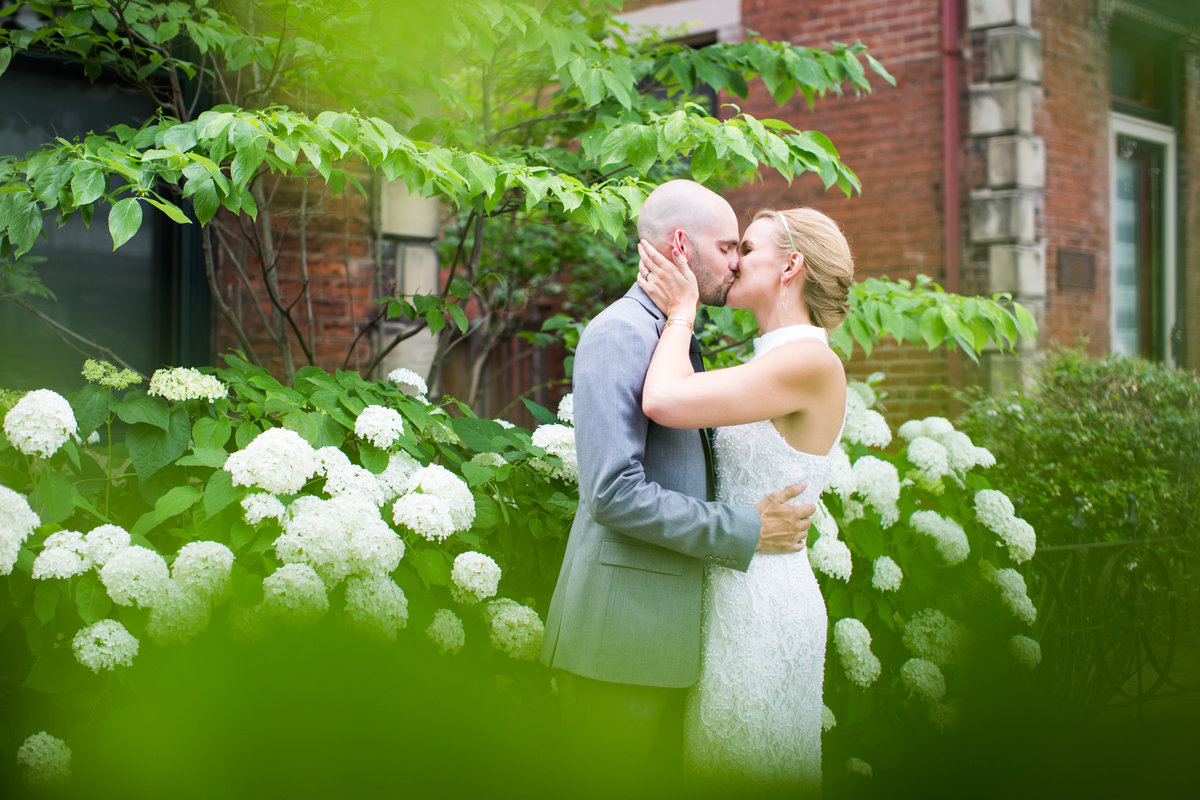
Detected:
[1033,0,1110,355]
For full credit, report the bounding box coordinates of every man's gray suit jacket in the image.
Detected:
[541,285,760,687]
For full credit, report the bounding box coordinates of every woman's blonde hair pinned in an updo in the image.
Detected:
[755,207,854,331]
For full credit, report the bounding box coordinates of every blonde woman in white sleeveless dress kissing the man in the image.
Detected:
[637,207,854,789]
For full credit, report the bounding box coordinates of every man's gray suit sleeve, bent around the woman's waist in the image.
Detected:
[574,303,761,571]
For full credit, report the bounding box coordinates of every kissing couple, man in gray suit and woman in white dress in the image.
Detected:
[541,180,853,790]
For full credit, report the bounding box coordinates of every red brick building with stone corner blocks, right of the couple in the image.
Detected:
[626,0,1200,417]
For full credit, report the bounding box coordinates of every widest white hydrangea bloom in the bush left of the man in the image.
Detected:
[275,494,404,587]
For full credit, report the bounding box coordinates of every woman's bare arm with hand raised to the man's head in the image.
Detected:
[637,242,842,428]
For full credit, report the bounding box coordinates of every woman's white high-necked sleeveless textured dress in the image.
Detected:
[684,325,840,788]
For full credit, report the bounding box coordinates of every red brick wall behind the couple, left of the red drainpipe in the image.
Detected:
[730,0,948,421]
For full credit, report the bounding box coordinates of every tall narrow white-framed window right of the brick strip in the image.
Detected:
[1109,113,1180,363]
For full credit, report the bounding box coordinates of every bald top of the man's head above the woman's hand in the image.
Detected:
[637,180,738,252]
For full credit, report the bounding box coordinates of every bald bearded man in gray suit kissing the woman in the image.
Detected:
[541,180,815,778]
